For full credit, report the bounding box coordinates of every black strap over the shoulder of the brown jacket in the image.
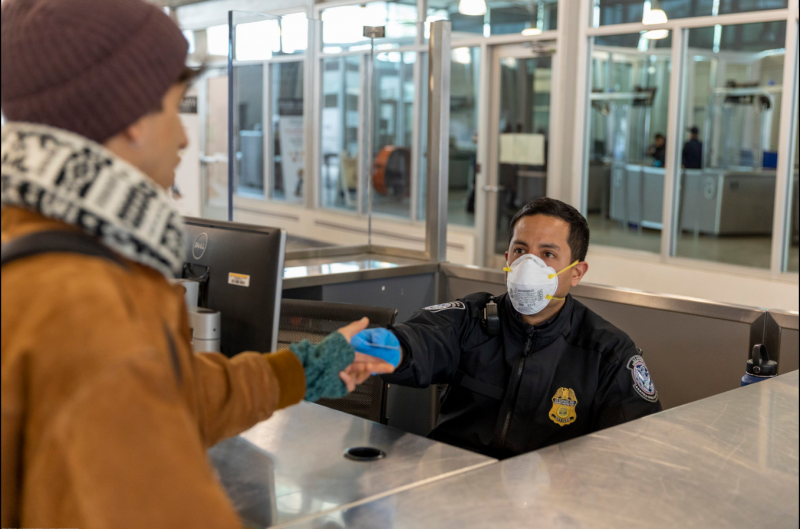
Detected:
[0,230,128,269]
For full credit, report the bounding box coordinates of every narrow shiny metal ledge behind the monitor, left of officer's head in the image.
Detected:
[283,253,439,289]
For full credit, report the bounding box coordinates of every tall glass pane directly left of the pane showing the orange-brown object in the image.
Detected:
[320,57,361,210]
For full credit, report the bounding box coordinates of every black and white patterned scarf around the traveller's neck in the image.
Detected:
[0,122,185,277]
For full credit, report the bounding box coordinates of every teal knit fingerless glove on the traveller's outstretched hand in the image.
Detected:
[289,332,356,402]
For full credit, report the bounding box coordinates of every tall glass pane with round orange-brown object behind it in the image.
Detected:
[371,51,417,218]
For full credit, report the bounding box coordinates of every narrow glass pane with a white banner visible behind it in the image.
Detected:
[270,62,305,202]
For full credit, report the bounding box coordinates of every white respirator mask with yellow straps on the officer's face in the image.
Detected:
[503,254,578,316]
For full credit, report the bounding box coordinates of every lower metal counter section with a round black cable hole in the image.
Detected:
[208,402,496,527]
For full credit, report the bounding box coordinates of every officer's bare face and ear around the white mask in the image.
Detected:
[506,215,589,297]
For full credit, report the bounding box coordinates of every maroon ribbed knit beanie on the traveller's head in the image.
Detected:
[0,0,188,143]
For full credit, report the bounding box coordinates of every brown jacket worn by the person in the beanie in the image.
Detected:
[0,208,305,529]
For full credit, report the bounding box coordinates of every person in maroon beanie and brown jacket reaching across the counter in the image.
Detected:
[0,0,392,529]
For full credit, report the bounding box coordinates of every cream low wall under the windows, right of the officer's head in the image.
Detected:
[585,248,800,311]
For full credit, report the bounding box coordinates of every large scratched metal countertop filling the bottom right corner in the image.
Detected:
[287,371,798,529]
